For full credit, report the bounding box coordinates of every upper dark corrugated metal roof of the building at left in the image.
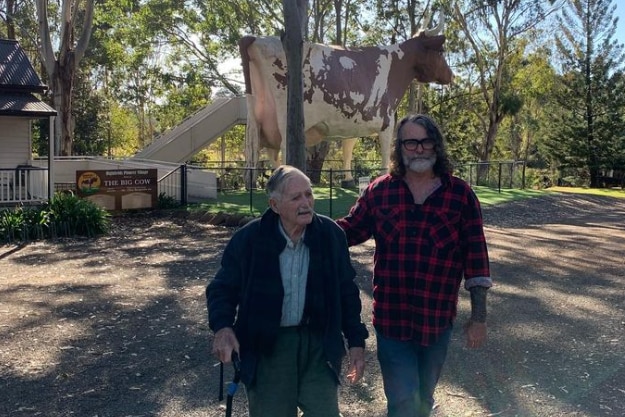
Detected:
[0,39,47,92]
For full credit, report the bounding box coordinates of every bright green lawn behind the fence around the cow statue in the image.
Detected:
[189,187,564,219]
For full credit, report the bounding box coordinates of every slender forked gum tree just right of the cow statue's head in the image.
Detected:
[446,0,554,172]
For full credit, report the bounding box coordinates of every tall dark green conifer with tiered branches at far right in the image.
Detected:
[549,0,625,187]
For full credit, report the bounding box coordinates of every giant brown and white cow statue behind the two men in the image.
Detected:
[239,15,453,184]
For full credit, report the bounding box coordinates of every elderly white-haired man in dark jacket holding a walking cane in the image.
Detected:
[206,165,368,417]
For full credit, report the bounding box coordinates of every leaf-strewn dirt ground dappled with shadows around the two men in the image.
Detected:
[0,194,625,417]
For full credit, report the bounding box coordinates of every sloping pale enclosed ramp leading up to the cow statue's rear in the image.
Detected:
[131,97,247,163]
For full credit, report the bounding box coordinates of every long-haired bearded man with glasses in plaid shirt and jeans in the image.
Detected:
[337,115,492,417]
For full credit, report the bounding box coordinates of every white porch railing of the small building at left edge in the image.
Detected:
[0,166,48,205]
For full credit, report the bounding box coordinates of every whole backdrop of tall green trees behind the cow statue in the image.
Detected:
[0,0,625,186]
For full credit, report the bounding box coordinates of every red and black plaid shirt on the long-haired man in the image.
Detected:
[338,175,491,346]
